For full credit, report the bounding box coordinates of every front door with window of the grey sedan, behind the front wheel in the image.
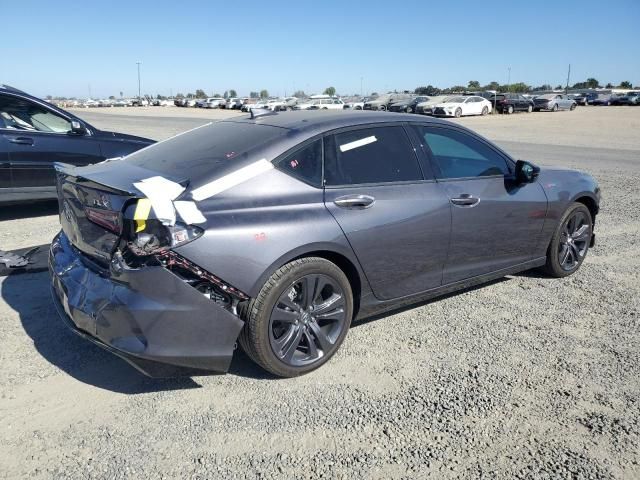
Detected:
[416,126,547,284]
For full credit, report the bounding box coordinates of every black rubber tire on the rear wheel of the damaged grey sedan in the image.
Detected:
[239,257,353,378]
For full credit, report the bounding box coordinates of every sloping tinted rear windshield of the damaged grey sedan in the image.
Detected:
[123,122,287,179]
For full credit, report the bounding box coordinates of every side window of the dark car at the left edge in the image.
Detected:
[0,96,71,133]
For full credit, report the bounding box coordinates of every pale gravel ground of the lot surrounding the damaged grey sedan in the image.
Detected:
[0,107,640,479]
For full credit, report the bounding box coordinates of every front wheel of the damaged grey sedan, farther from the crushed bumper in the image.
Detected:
[544,202,593,277]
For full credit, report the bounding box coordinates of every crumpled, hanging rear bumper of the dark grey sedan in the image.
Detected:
[49,232,243,377]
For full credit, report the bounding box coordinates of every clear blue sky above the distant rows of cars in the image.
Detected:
[0,0,640,98]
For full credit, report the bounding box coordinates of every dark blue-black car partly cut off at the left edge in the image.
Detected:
[0,85,153,203]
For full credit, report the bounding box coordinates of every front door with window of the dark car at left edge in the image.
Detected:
[0,96,104,190]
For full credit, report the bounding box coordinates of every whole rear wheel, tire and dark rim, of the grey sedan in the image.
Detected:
[239,257,353,377]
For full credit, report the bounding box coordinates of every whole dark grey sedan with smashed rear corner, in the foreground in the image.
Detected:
[50,112,600,377]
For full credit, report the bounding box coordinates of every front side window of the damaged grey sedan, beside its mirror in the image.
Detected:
[414,125,509,179]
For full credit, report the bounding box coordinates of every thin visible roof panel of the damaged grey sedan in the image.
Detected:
[222,110,449,136]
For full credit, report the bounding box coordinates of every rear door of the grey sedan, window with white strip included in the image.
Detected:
[324,123,451,300]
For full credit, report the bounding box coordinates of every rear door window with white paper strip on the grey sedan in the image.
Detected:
[324,127,423,186]
